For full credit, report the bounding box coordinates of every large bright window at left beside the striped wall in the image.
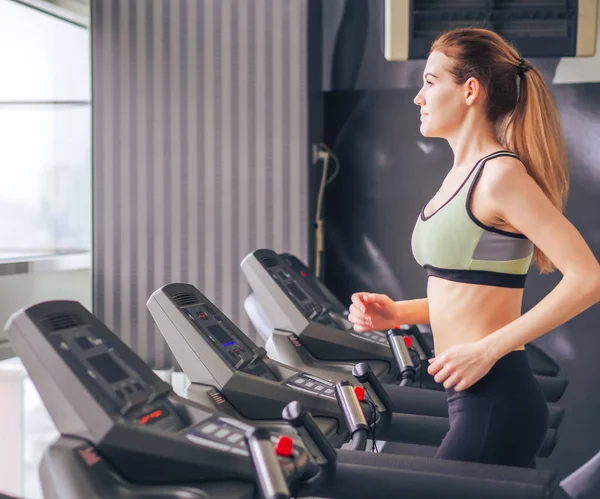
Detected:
[0,0,92,260]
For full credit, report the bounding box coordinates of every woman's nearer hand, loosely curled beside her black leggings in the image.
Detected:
[427,341,498,392]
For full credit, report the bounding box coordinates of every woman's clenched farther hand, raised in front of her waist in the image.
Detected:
[348,293,399,333]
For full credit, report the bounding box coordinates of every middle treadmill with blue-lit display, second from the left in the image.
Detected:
[147,283,557,457]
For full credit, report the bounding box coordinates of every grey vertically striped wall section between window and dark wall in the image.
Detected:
[92,0,309,368]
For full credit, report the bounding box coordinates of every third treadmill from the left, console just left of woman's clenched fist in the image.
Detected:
[241,249,567,402]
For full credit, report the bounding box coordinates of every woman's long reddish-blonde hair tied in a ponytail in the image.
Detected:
[431,28,569,273]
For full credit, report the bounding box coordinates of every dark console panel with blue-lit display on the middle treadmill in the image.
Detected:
[182,303,279,381]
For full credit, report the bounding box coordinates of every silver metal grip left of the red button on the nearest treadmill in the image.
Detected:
[246,428,291,499]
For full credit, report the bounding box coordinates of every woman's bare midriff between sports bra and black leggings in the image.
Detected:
[427,276,524,355]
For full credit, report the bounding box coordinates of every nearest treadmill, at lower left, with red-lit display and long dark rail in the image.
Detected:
[6,300,561,499]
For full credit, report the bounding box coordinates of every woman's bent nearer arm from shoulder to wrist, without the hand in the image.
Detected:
[483,160,600,358]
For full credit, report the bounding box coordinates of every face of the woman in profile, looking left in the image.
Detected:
[414,52,468,138]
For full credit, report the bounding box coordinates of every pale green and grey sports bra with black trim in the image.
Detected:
[411,151,533,288]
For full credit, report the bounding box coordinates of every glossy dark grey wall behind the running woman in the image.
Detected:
[323,0,600,486]
